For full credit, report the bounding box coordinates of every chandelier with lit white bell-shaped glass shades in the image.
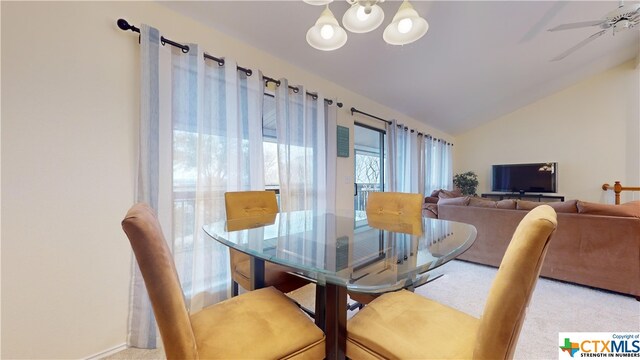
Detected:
[304,0,429,51]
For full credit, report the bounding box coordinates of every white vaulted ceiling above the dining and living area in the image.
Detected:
[160,0,640,135]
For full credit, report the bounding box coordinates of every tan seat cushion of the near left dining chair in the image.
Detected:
[191,288,325,359]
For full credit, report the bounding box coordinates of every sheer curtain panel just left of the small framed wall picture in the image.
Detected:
[275,79,337,213]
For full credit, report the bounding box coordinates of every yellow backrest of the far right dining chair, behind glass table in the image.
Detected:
[366,192,424,216]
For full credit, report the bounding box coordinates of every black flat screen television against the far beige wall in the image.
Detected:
[491,162,558,193]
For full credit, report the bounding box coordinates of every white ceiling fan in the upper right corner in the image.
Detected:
[549,0,640,61]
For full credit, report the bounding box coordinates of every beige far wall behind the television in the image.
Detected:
[454,61,640,202]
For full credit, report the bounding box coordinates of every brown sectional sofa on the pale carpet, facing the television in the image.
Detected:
[423,197,640,300]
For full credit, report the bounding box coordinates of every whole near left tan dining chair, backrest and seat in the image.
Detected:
[122,204,325,359]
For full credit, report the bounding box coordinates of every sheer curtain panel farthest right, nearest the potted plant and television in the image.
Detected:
[424,136,453,195]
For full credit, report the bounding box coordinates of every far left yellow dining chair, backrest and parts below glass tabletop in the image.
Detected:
[224,191,309,296]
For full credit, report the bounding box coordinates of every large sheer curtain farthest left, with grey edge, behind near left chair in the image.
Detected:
[127,25,264,348]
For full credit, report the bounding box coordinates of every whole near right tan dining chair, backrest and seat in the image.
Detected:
[347,205,557,359]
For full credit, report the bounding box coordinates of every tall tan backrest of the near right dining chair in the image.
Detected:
[473,205,557,359]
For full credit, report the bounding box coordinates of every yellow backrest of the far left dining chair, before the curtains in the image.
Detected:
[224,191,278,220]
